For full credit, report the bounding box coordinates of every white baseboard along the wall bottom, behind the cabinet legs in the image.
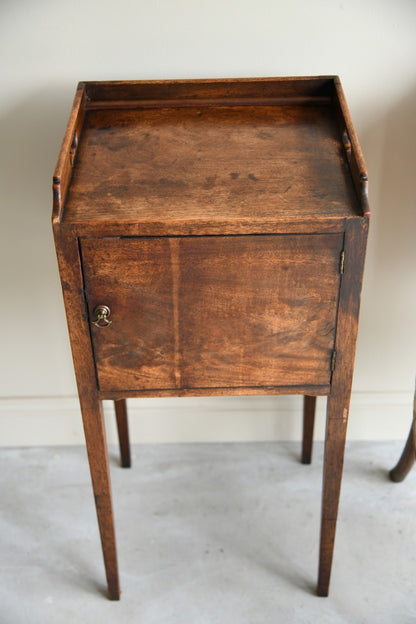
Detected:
[0,392,413,446]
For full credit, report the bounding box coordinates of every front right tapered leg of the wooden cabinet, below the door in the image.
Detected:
[317,396,349,596]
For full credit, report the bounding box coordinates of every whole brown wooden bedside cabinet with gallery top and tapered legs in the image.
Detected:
[53,77,369,599]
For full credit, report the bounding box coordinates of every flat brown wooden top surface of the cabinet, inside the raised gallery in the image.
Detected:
[63,105,360,223]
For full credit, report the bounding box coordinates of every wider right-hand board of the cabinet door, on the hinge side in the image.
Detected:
[178,235,342,387]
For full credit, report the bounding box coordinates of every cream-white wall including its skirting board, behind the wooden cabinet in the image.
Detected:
[0,0,416,444]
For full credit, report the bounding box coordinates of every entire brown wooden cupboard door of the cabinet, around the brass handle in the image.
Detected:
[82,234,343,391]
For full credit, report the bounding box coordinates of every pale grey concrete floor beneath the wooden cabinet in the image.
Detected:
[0,442,416,624]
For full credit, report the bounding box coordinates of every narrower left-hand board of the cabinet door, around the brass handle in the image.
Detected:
[81,238,175,390]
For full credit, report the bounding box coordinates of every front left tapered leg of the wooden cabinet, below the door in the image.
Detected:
[80,393,120,600]
